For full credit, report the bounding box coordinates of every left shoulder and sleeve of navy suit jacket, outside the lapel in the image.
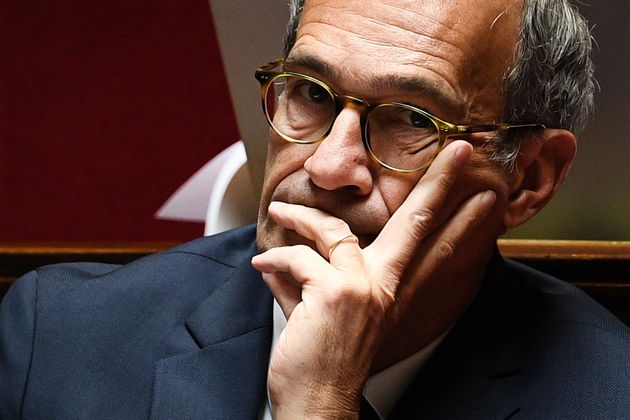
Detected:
[0,227,256,418]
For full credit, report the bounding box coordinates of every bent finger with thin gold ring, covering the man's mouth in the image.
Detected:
[269,201,361,268]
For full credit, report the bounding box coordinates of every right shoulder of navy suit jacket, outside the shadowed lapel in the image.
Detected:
[505,261,630,418]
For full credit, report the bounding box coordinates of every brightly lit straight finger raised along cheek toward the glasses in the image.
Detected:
[368,141,472,274]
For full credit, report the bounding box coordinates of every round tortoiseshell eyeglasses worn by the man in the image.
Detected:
[256,59,545,172]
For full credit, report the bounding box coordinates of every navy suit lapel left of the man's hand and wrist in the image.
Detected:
[151,254,272,419]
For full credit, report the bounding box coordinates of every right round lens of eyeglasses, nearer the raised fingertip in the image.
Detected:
[365,104,440,171]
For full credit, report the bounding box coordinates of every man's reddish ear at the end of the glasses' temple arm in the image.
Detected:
[503,129,577,228]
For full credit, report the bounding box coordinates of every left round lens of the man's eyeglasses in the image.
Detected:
[265,76,335,143]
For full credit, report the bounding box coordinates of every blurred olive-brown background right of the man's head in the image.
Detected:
[508,0,630,240]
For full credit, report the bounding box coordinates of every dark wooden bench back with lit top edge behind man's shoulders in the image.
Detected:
[0,240,630,325]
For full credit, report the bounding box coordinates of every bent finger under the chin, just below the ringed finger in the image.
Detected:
[252,245,334,284]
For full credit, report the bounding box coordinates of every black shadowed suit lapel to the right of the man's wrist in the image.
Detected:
[390,252,527,419]
